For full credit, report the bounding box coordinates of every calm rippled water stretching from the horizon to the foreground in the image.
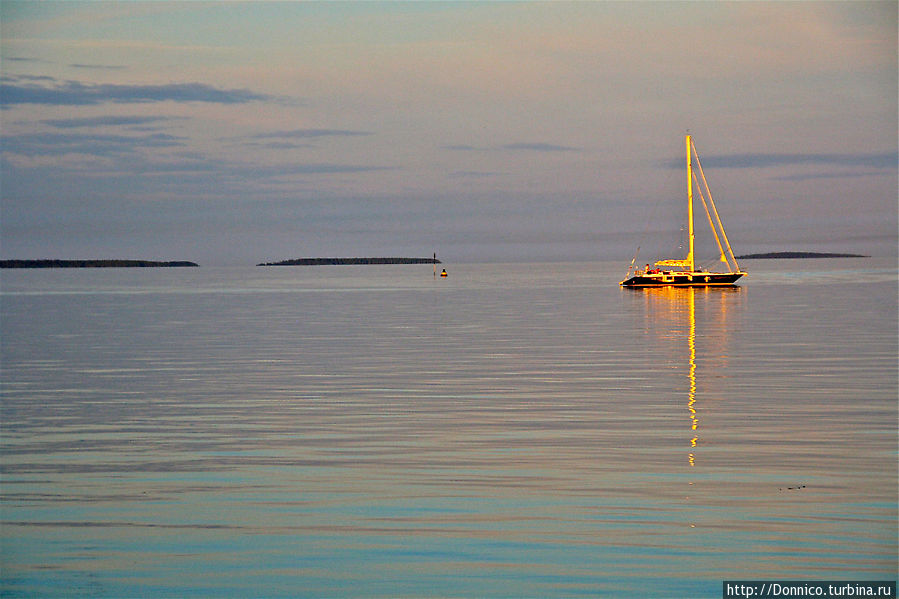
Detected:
[0,259,899,597]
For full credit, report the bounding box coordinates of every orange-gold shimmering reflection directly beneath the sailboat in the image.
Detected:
[637,286,745,468]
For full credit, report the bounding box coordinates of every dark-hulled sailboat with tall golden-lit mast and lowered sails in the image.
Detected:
[619,135,746,287]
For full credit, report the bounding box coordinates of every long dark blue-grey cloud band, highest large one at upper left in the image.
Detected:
[0,78,273,107]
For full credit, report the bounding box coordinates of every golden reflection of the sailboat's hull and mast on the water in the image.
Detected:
[641,286,742,468]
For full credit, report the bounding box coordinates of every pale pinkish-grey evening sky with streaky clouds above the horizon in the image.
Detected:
[0,0,899,266]
